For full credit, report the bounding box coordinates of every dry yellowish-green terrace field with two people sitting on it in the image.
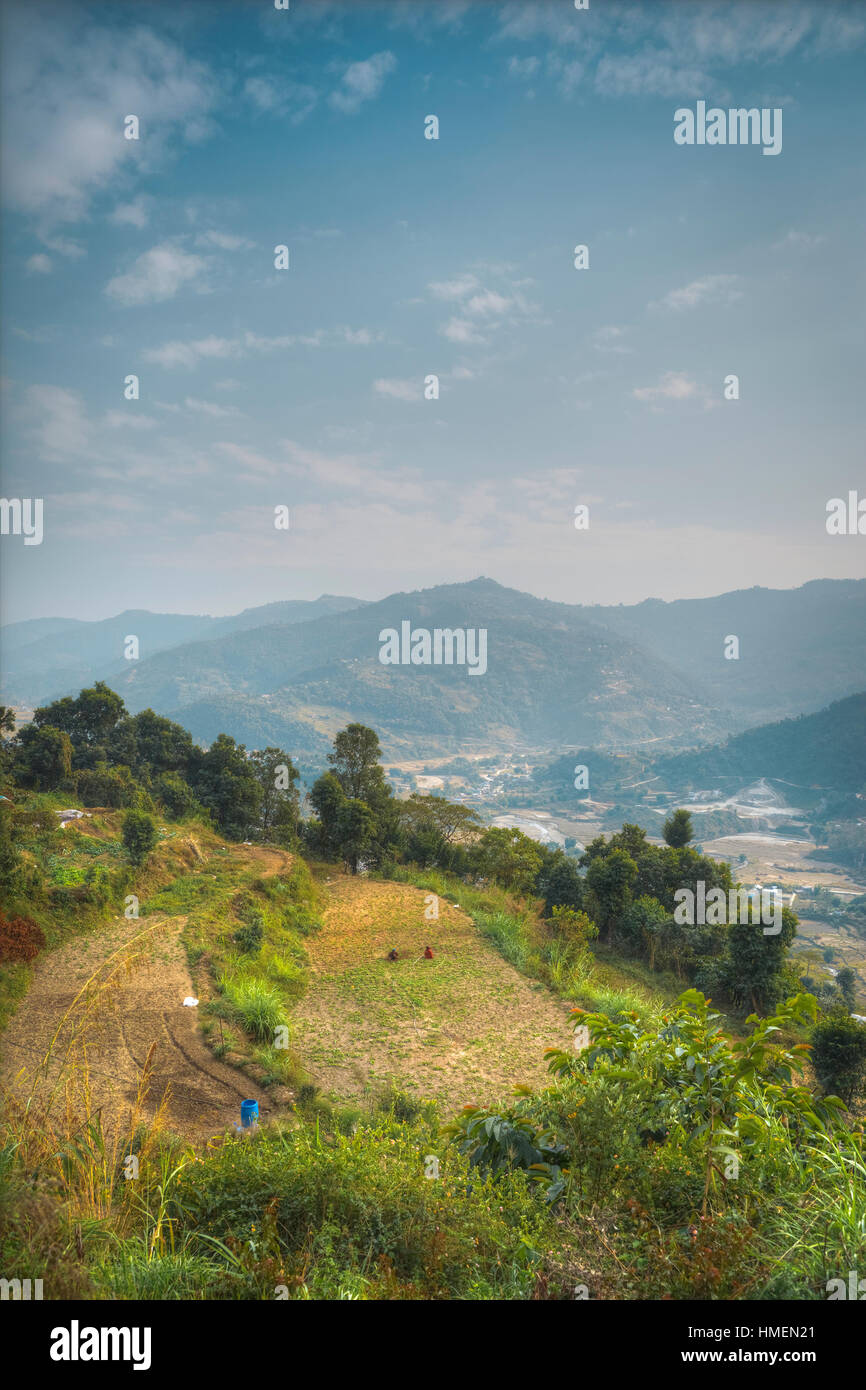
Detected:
[292,872,571,1112]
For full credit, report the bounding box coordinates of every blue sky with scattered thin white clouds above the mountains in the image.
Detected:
[0,0,866,621]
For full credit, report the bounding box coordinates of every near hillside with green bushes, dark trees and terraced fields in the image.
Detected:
[0,687,866,1300]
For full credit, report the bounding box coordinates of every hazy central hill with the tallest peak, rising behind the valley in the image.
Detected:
[109,580,733,755]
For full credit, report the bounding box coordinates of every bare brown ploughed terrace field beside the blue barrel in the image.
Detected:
[0,845,291,1141]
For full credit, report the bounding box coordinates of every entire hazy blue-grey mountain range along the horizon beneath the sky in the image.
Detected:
[0,578,866,760]
